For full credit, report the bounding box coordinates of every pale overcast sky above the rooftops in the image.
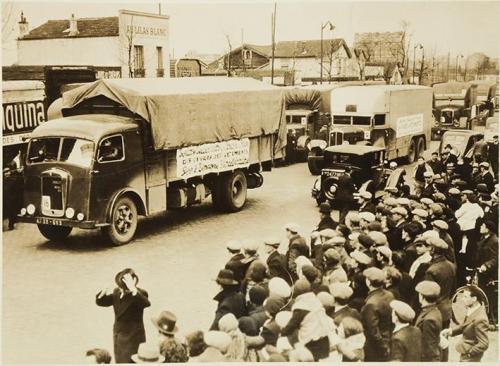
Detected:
[2,0,500,64]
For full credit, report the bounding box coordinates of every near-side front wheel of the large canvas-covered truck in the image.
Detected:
[102,196,138,246]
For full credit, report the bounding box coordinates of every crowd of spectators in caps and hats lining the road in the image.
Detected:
[89,144,498,363]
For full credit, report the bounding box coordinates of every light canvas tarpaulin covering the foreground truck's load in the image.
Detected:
[63,77,286,152]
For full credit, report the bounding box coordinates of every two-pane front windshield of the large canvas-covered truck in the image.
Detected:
[28,137,94,168]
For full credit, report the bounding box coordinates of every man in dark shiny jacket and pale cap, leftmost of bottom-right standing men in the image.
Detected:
[361,267,394,362]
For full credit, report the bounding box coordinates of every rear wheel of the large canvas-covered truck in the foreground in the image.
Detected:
[219,170,247,212]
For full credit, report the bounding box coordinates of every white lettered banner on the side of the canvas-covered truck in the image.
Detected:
[177,139,250,179]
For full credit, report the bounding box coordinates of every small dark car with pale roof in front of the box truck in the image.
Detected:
[312,145,386,208]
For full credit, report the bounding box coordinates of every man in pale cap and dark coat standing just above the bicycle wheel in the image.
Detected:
[425,238,456,362]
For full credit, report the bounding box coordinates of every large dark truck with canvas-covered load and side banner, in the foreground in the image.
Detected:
[19,77,286,245]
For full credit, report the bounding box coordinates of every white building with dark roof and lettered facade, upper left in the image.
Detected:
[17,10,170,78]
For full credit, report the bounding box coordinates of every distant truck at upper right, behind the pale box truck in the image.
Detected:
[431,81,478,141]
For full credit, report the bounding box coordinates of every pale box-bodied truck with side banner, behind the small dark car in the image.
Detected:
[310,85,433,173]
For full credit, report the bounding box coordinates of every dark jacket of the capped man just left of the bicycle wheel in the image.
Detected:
[415,305,443,362]
